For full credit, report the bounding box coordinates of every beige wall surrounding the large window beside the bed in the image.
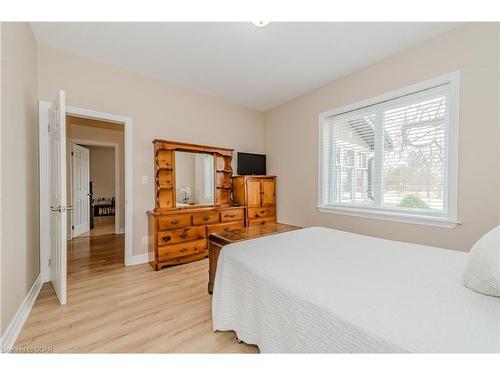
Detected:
[265,24,500,251]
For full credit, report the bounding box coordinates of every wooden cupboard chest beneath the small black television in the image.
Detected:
[233,176,276,226]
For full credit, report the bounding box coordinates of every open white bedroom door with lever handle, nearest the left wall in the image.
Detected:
[49,90,67,305]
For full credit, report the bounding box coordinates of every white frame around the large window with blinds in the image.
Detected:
[317,71,461,228]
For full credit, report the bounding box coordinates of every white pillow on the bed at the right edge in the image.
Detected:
[464,225,500,297]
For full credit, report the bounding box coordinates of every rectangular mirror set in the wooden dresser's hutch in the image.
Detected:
[175,151,215,208]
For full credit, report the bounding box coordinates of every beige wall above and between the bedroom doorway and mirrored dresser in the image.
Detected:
[38,45,264,254]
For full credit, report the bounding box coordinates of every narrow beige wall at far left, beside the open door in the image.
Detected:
[1,22,39,334]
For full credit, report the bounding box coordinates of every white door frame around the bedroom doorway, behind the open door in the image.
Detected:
[38,101,135,282]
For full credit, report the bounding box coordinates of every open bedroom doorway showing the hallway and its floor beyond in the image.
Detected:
[66,115,125,272]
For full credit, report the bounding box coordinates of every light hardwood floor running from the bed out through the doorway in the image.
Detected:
[15,235,258,353]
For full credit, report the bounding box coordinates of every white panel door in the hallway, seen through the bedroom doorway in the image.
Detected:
[71,144,90,237]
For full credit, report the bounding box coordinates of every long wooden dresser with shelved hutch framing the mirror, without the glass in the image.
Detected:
[148,140,246,270]
